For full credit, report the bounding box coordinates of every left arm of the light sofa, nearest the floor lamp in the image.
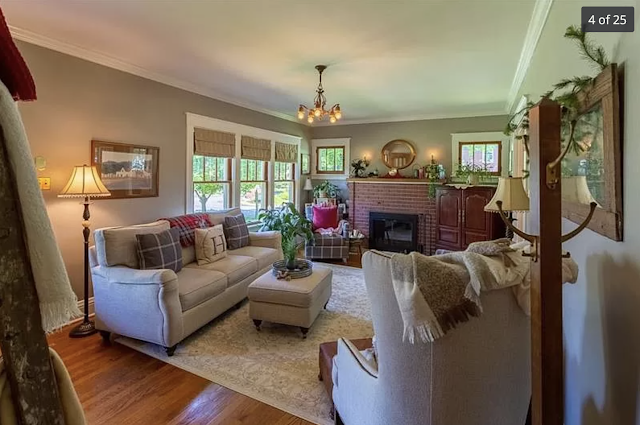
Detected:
[91,266,183,347]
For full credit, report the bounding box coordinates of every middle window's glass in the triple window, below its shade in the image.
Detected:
[240,159,267,221]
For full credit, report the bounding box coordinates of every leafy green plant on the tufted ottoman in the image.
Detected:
[258,202,313,270]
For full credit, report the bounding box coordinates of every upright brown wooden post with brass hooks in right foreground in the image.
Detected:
[528,100,564,425]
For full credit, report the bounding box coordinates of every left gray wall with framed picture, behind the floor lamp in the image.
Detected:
[18,42,309,296]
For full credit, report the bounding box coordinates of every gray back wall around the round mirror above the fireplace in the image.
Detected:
[311,115,508,180]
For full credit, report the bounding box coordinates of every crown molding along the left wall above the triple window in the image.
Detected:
[9,25,303,124]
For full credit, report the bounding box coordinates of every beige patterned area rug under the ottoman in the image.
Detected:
[116,264,373,425]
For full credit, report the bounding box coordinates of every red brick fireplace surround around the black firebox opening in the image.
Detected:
[347,178,436,254]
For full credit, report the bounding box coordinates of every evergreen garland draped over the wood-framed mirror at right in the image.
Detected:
[504,25,611,178]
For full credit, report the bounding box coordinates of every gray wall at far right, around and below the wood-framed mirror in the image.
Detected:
[563,31,640,425]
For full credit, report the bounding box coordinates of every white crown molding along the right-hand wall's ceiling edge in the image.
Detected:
[506,0,553,113]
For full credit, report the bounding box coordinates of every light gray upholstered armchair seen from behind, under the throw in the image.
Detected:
[332,251,531,425]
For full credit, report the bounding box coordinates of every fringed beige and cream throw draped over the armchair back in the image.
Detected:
[391,242,578,343]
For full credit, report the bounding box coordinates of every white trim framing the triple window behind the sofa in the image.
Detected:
[185,112,302,213]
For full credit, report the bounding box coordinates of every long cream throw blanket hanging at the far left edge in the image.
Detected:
[0,83,80,332]
